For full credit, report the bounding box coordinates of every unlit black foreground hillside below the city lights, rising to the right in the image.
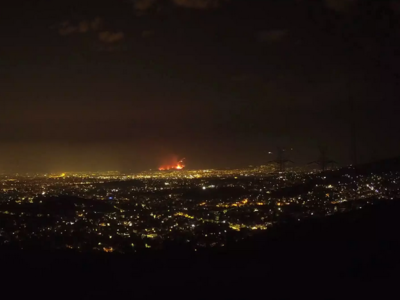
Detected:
[0,201,400,299]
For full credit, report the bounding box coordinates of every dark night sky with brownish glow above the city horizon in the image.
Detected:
[0,0,400,172]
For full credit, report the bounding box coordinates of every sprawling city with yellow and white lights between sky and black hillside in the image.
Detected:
[0,166,400,253]
